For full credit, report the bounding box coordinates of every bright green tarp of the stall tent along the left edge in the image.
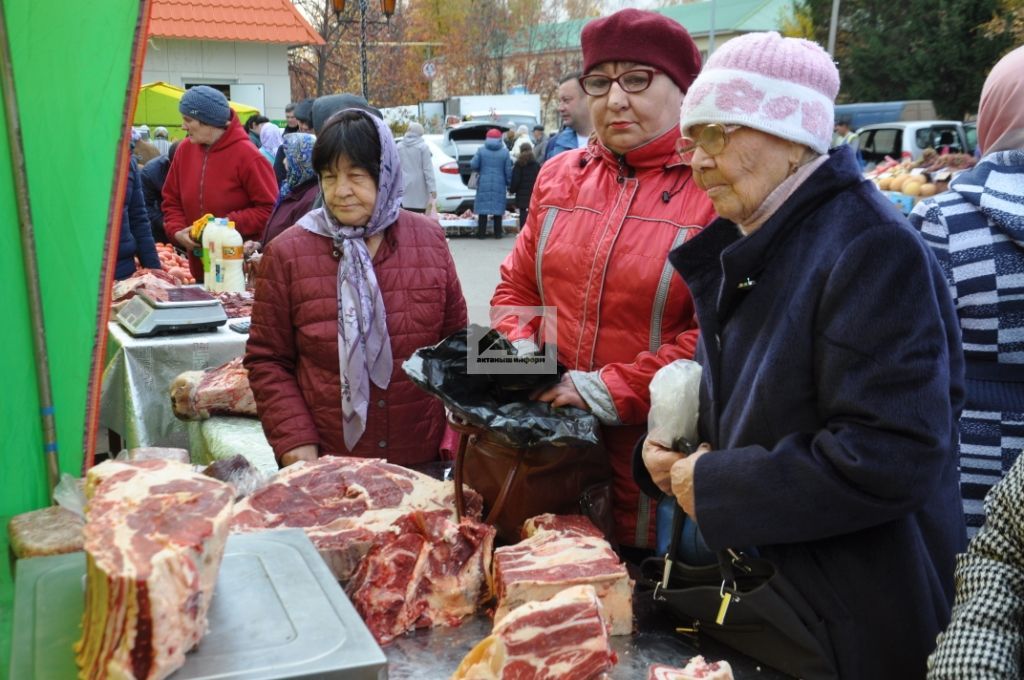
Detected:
[0,0,146,679]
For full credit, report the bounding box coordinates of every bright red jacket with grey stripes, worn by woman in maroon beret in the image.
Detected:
[490,128,715,547]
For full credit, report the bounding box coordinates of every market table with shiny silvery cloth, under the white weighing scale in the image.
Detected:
[99,318,249,454]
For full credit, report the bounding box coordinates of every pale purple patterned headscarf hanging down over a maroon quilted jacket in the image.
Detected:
[298,109,402,451]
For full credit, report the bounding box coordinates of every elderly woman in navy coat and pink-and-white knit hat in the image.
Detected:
[640,33,966,680]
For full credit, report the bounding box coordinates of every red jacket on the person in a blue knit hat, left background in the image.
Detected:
[163,111,278,282]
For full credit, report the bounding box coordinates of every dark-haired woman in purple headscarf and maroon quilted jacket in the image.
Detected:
[245,109,467,465]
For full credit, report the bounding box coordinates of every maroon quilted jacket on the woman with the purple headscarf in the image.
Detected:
[245,211,467,465]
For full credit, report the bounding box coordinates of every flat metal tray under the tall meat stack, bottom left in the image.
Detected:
[10,529,387,680]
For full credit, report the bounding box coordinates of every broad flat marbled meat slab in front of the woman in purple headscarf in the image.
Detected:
[231,456,483,581]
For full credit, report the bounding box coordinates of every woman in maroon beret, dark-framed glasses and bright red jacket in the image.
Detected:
[490,9,714,548]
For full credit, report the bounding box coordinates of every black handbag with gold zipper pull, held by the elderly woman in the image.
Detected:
[641,507,837,680]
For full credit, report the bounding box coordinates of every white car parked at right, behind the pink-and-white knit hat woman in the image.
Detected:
[857,121,971,167]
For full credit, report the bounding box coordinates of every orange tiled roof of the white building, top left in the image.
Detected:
[150,0,324,45]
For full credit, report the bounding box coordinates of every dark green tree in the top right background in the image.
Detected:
[795,0,1011,119]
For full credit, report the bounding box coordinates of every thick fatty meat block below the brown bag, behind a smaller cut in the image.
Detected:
[493,514,633,635]
